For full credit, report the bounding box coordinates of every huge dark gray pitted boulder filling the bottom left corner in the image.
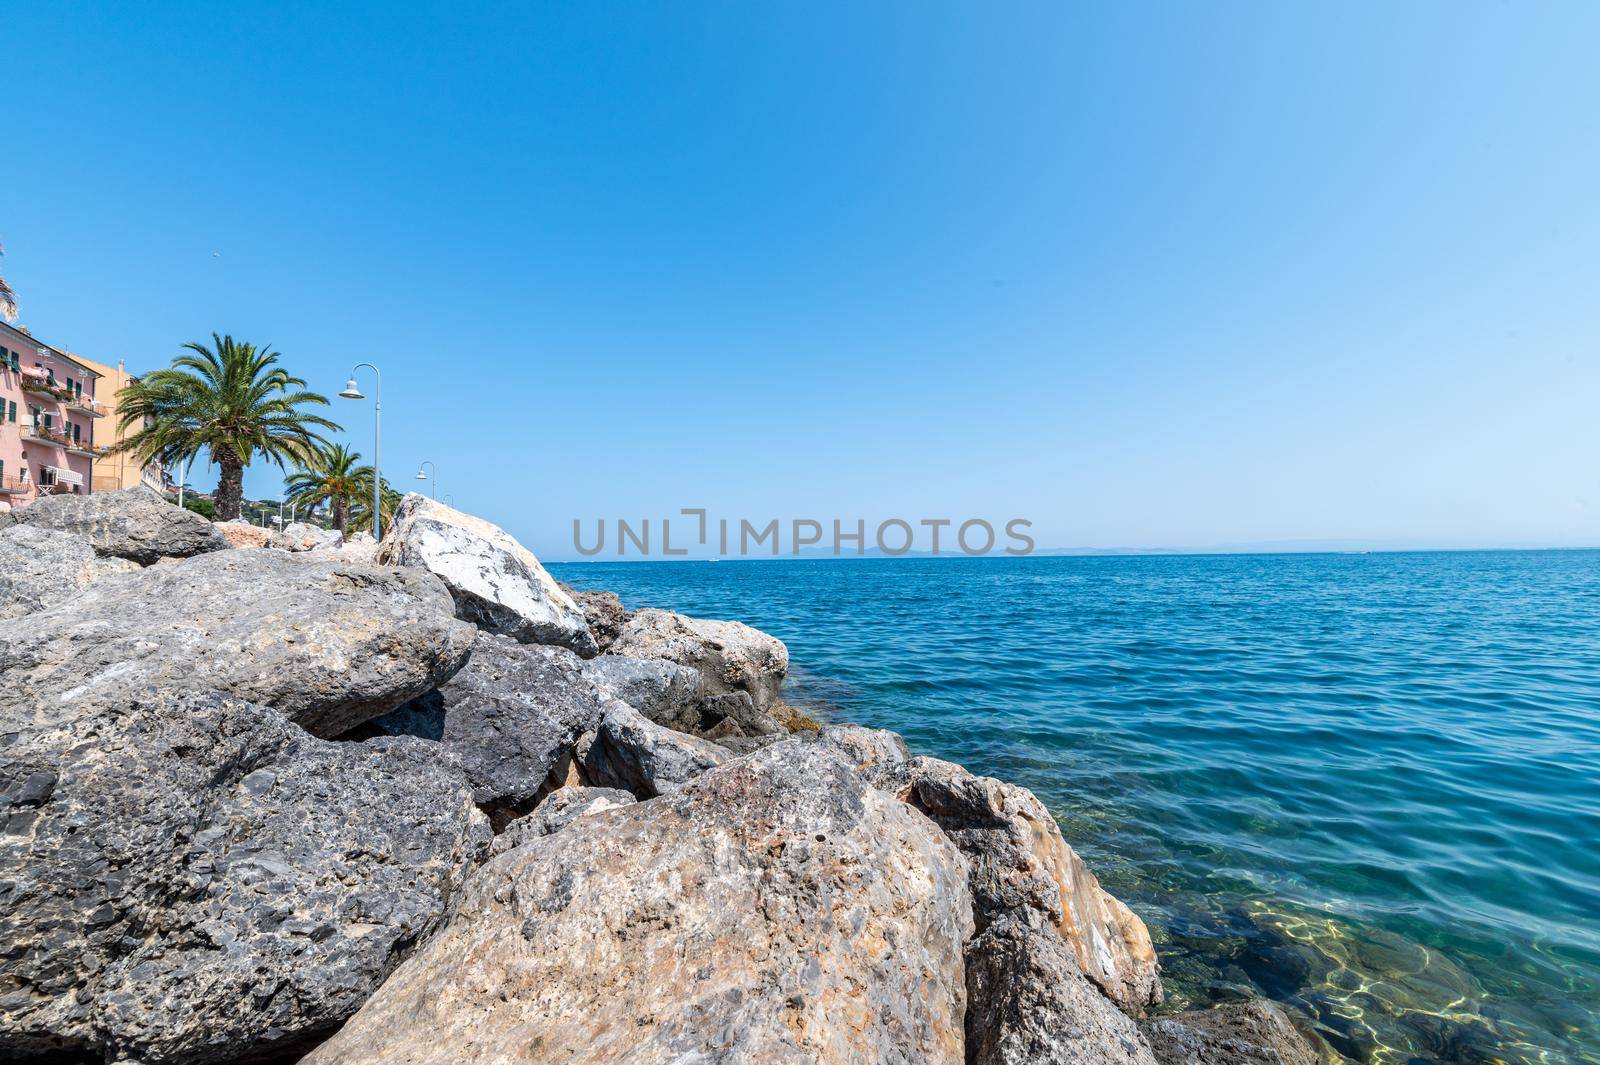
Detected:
[0,686,490,1065]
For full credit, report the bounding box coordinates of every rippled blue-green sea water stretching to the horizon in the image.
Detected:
[552,552,1600,1063]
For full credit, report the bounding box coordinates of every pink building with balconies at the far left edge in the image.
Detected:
[0,323,106,507]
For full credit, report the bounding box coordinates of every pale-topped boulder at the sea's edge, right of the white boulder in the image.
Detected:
[608,609,789,710]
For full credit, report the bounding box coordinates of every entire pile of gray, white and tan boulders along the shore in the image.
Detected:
[0,489,1323,1065]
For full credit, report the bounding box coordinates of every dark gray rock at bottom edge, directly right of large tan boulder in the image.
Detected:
[966,913,1155,1065]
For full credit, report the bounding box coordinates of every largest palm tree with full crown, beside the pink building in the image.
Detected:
[117,333,339,521]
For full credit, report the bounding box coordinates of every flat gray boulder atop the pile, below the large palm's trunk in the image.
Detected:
[14,485,227,566]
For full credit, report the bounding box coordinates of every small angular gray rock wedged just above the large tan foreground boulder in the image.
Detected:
[578,700,731,798]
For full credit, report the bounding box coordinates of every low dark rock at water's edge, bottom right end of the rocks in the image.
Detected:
[1141,999,1325,1065]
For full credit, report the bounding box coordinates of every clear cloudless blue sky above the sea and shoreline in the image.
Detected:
[0,2,1600,558]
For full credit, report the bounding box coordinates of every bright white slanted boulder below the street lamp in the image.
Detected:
[379,493,598,657]
